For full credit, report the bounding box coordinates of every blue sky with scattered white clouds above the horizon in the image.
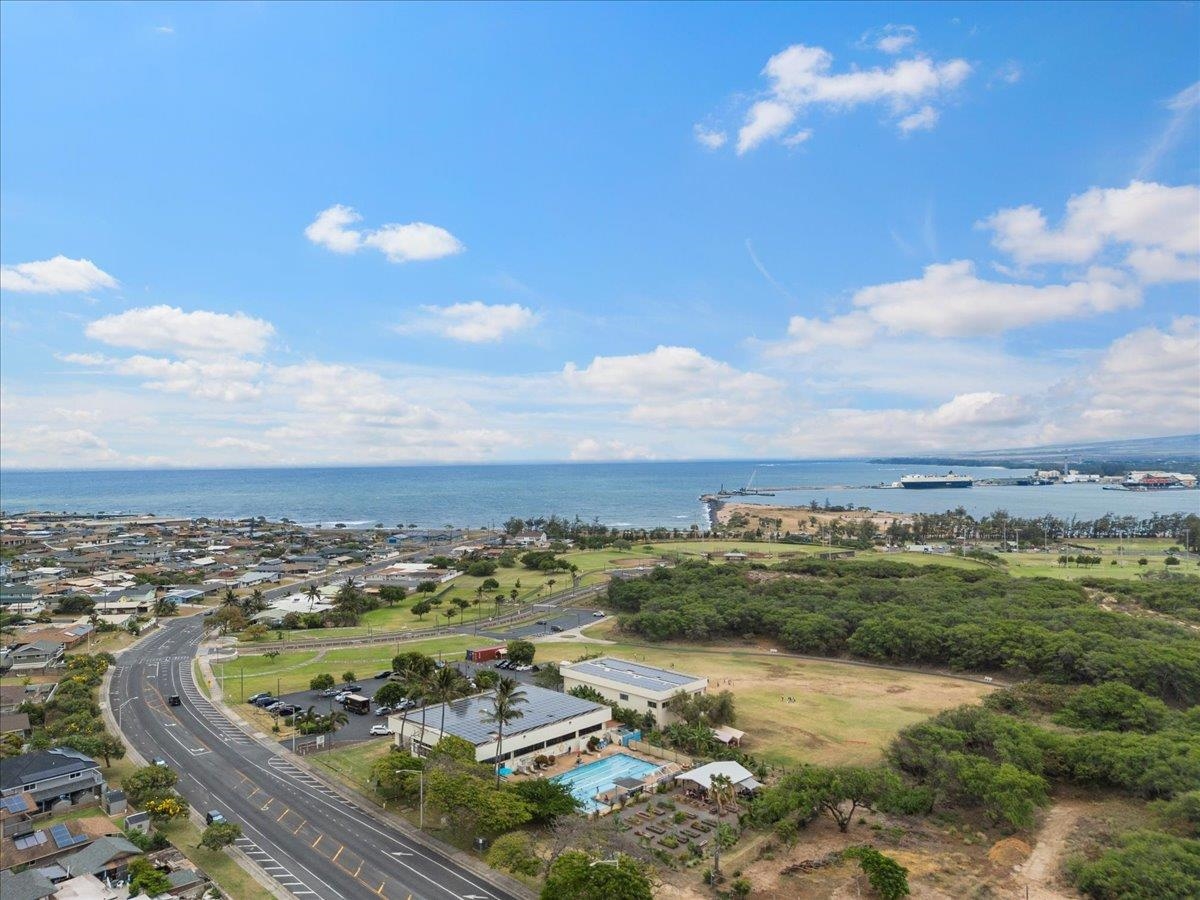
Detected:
[0,2,1200,467]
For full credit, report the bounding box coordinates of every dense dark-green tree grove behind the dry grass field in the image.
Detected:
[608,559,1200,703]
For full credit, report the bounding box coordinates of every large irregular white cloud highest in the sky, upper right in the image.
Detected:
[737,42,971,155]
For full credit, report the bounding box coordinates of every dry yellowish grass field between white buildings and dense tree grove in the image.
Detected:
[549,620,992,766]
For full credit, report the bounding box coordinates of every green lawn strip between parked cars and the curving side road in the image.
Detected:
[212,636,482,702]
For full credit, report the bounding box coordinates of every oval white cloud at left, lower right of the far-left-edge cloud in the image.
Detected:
[85,305,275,356]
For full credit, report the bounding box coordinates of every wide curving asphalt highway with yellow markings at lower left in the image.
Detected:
[108,616,516,900]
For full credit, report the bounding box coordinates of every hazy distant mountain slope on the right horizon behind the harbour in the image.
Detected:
[872,434,1200,475]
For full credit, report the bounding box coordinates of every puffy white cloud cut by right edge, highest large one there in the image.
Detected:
[979,181,1200,273]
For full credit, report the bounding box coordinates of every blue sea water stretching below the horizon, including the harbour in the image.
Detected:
[0,460,1200,528]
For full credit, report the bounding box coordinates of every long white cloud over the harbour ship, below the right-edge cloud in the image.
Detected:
[853,260,1141,337]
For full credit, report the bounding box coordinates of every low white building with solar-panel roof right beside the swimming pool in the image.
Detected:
[388,684,612,766]
